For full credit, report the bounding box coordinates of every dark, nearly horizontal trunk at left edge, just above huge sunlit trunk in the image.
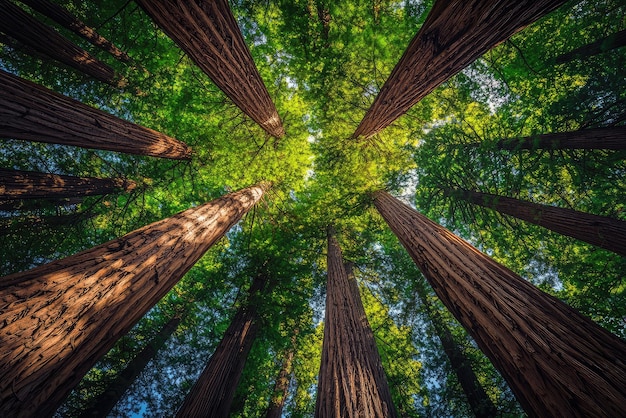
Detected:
[0,168,137,201]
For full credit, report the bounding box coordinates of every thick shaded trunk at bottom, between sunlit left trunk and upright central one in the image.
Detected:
[176,275,267,418]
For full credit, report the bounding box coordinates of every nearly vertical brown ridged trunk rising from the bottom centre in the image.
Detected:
[315,228,397,418]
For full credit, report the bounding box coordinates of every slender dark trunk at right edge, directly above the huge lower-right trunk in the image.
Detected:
[444,189,626,256]
